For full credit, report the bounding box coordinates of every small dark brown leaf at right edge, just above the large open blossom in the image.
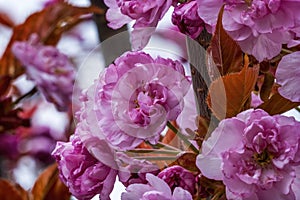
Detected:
[258,93,300,115]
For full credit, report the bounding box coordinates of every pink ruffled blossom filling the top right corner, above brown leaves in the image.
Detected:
[197,0,300,62]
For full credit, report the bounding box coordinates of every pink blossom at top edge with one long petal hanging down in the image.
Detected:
[104,0,172,50]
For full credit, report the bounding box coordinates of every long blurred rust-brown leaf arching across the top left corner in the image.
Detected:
[0,2,103,78]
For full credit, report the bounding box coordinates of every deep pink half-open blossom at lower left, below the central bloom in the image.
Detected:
[53,134,117,200]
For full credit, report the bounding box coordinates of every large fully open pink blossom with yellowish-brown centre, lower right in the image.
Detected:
[196,109,300,199]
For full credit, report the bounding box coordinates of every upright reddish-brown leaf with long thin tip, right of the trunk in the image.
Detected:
[208,6,243,76]
